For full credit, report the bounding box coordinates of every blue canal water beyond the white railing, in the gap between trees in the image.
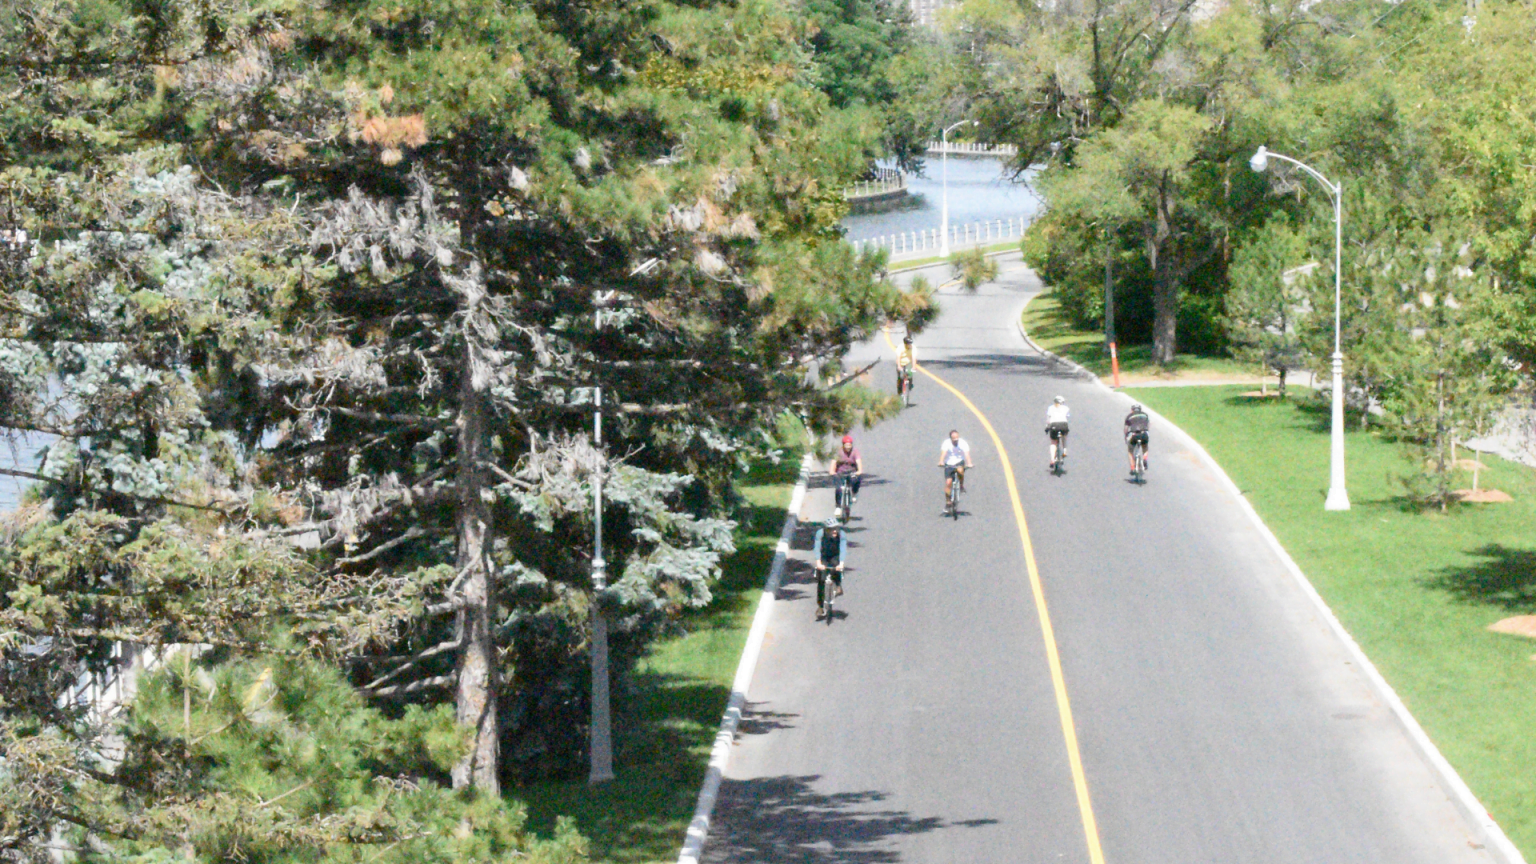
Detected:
[843,155,1041,241]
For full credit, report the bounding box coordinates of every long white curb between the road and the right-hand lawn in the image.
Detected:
[1014,305,1525,864]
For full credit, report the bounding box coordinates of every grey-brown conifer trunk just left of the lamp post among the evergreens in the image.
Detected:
[453,340,501,795]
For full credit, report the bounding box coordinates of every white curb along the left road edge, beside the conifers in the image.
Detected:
[677,454,816,864]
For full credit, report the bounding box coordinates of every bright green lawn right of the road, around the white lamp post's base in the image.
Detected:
[1127,387,1536,861]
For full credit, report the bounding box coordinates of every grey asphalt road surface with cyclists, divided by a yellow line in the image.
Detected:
[703,257,1490,864]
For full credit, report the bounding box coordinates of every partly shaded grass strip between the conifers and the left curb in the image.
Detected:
[507,454,800,864]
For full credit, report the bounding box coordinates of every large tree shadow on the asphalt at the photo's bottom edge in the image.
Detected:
[703,775,997,864]
